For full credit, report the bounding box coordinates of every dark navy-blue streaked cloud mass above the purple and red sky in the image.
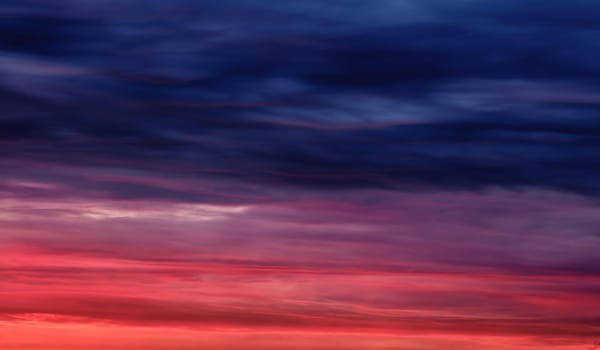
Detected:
[0,0,600,201]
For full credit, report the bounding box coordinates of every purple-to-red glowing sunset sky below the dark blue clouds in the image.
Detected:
[0,192,600,350]
